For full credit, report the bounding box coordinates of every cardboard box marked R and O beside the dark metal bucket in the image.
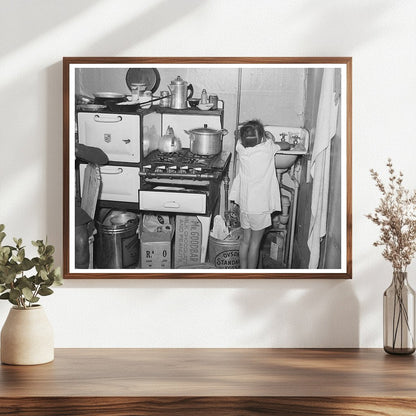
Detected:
[140,216,174,269]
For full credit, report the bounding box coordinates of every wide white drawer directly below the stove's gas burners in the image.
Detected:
[139,191,206,214]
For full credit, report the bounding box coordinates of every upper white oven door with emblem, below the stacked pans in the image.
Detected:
[78,112,140,163]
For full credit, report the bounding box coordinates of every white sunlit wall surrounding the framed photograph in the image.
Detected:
[0,0,416,347]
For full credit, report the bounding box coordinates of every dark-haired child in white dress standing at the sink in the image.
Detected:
[230,120,290,269]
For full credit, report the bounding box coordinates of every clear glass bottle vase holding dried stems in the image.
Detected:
[383,271,415,354]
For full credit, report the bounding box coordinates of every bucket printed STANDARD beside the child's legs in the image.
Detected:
[208,235,240,269]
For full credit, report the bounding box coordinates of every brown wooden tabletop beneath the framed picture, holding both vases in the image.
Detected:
[0,349,416,416]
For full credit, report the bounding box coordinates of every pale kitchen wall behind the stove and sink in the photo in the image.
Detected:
[76,67,306,161]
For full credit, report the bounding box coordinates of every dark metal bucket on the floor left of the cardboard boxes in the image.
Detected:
[94,211,139,269]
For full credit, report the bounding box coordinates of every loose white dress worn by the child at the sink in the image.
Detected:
[229,140,281,214]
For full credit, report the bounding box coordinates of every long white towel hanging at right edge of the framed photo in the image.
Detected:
[308,68,339,269]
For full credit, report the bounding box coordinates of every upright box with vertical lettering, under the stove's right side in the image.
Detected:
[174,215,202,268]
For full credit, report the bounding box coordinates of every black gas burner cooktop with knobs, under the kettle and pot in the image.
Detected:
[140,149,231,180]
